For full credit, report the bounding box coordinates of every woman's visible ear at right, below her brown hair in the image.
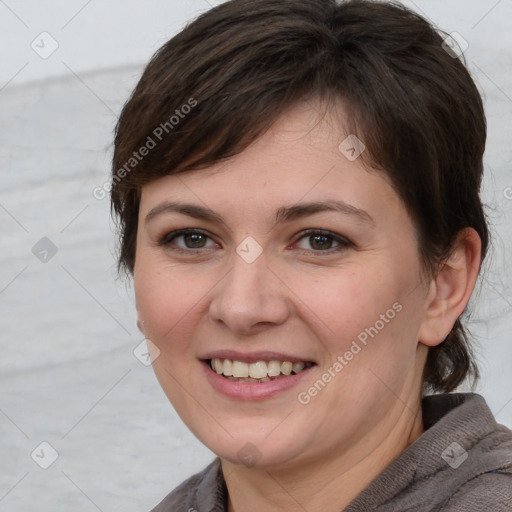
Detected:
[418,228,482,347]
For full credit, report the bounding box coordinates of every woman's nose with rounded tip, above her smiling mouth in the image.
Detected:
[209,253,290,335]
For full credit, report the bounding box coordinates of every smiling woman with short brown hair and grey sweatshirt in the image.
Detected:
[112,0,512,512]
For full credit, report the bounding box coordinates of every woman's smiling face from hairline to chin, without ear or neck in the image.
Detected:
[134,102,434,467]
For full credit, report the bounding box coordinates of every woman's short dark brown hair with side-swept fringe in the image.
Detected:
[111,0,489,391]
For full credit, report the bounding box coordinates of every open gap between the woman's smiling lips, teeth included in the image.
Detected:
[206,358,315,383]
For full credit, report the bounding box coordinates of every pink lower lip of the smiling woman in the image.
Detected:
[202,361,314,400]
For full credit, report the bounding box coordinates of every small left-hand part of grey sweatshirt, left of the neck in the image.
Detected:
[151,459,226,512]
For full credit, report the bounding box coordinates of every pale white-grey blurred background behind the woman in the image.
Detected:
[0,0,512,512]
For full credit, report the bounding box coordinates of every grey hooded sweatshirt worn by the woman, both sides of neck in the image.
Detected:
[151,393,512,512]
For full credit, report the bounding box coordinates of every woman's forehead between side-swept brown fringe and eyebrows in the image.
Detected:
[141,100,401,222]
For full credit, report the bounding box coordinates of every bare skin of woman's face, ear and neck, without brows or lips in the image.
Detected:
[134,100,480,512]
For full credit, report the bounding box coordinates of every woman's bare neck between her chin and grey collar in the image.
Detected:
[222,404,423,512]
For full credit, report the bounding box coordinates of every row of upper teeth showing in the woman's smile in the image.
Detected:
[211,358,306,379]
